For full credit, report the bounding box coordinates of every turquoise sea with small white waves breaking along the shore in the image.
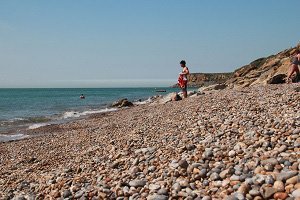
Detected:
[0,88,178,142]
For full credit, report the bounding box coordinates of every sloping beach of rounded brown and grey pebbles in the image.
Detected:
[0,84,300,200]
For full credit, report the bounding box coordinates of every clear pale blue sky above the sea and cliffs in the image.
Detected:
[0,0,300,87]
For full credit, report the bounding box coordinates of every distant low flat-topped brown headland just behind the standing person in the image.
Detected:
[173,73,233,87]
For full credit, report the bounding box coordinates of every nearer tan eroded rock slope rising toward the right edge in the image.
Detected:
[226,44,300,87]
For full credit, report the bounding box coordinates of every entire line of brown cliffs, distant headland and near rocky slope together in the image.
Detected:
[174,44,300,88]
